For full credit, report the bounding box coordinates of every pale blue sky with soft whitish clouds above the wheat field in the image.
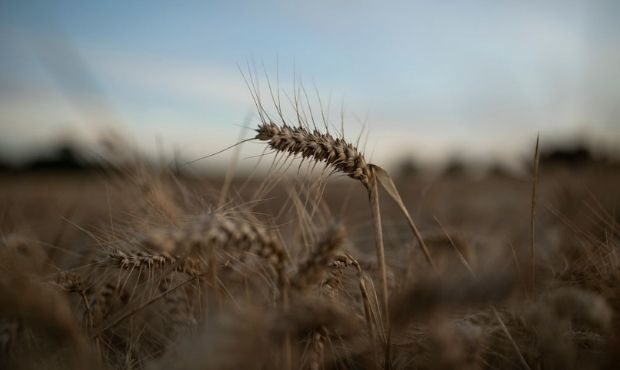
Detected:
[0,0,620,166]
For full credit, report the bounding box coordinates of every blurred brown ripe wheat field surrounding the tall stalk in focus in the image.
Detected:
[0,155,620,369]
